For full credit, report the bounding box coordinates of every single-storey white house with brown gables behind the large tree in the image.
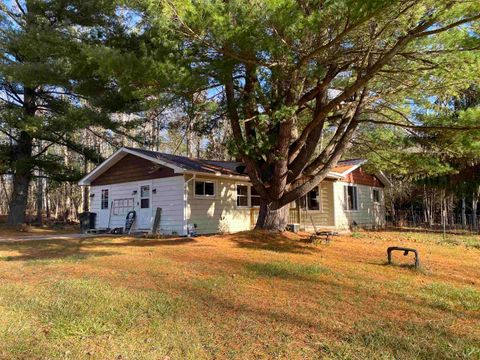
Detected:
[79,147,388,235]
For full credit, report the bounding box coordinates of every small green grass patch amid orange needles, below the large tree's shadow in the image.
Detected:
[246,261,331,279]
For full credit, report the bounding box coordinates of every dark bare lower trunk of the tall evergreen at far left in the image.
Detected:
[7,131,32,225]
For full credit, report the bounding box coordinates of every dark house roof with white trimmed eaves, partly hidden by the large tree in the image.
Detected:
[79,147,386,185]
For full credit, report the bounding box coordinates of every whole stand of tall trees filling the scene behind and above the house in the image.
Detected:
[0,0,480,229]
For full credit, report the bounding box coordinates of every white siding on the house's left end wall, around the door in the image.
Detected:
[90,176,185,235]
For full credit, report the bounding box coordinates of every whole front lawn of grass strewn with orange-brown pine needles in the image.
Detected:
[0,232,480,360]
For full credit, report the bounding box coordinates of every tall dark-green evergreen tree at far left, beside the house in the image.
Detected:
[0,0,144,224]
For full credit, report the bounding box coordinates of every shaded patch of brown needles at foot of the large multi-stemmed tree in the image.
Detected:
[229,230,321,254]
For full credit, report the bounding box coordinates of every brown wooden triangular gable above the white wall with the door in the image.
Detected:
[91,154,181,186]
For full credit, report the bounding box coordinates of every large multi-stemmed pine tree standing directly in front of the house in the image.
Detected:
[135,0,480,229]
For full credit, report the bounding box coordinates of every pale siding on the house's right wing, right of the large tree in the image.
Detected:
[334,181,385,230]
